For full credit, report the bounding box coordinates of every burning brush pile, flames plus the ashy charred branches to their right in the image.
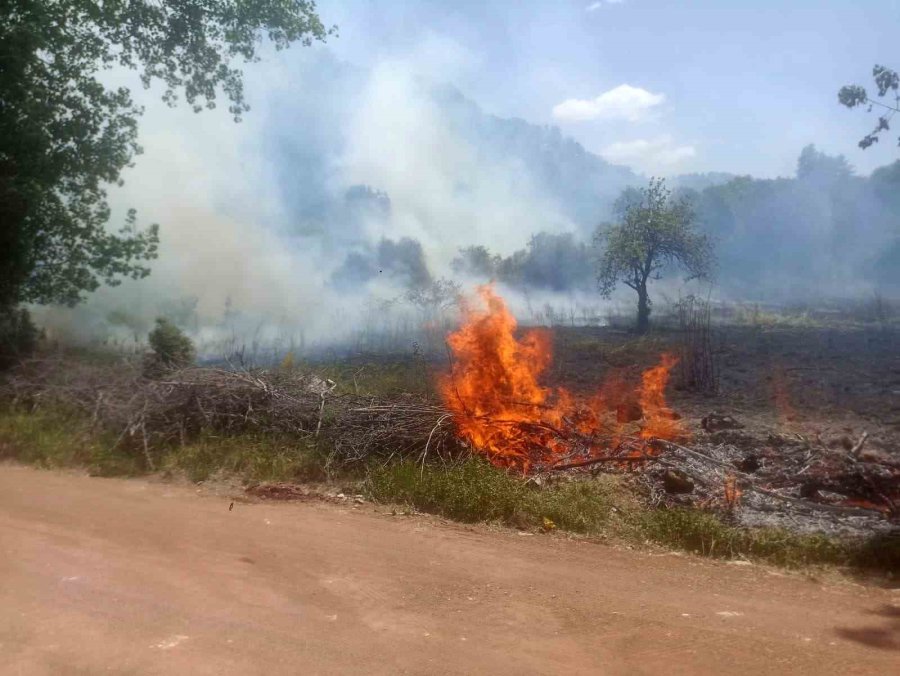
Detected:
[439,287,900,533]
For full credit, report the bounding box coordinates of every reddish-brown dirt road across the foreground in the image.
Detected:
[0,465,900,675]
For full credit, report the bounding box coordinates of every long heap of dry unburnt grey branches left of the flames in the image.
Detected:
[0,357,462,469]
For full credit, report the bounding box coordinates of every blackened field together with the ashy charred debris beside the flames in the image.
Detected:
[549,326,900,534]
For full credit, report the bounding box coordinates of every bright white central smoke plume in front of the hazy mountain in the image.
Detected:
[340,59,575,262]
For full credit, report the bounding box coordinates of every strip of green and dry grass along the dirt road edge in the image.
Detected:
[0,396,900,575]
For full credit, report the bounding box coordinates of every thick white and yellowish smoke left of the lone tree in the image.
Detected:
[42,36,592,352]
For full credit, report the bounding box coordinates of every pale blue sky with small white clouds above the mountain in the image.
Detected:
[319,0,900,176]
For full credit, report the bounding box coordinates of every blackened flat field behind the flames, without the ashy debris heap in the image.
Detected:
[550,327,900,454]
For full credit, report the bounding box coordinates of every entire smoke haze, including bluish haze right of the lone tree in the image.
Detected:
[29,35,900,352]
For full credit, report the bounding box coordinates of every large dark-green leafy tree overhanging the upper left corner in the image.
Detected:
[0,0,334,310]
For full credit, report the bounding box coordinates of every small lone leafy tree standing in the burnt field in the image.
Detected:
[595,179,713,334]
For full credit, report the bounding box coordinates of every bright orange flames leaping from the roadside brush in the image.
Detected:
[438,285,684,470]
